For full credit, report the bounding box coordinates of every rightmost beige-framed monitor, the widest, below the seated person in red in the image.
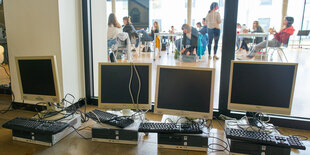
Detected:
[228,61,298,114]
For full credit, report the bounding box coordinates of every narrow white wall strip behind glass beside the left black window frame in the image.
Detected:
[91,0,108,96]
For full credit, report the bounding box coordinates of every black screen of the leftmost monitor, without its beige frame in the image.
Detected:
[17,59,56,96]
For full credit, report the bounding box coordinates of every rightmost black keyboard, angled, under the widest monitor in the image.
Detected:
[226,128,306,150]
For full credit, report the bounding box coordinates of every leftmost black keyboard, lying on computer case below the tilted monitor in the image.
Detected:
[2,117,69,134]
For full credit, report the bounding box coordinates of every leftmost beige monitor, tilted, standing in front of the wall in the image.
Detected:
[16,56,60,103]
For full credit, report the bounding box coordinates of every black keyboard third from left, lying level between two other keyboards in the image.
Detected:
[138,122,202,134]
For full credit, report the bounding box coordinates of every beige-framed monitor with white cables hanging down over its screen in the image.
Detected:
[98,63,152,110]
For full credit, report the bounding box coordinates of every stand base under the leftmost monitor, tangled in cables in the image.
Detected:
[34,102,66,120]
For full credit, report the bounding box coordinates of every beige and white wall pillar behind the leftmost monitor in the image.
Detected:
[4,0,85,103]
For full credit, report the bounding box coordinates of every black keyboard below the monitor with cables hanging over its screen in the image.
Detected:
[87,109,134,128]
